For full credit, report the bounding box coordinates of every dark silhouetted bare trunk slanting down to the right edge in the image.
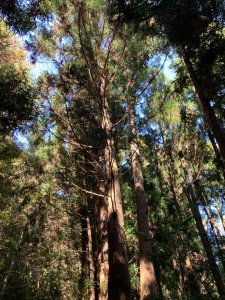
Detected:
[181,49,225,159]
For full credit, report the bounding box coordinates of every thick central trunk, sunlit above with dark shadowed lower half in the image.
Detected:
[101,92,130,300]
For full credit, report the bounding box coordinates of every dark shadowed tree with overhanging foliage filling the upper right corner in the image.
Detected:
[112,0,225,159]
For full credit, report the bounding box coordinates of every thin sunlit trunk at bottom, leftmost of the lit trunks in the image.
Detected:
[87,216,95,300]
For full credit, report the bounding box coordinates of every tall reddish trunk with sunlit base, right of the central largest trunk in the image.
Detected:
[129,104,159,300]
